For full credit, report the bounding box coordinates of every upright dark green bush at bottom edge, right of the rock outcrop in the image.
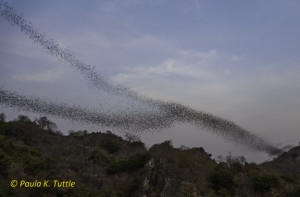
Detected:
[211,163,236,195]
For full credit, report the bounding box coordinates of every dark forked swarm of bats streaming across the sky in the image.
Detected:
[0,1,282,155]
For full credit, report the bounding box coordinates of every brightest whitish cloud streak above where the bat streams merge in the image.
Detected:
[112,50,239,83]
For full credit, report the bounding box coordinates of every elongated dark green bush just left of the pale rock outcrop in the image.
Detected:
[106,153,151,174]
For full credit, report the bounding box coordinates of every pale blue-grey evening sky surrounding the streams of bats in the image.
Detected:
[0,0,300,162]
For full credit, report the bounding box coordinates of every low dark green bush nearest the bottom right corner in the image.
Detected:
[252,175,280,194]
